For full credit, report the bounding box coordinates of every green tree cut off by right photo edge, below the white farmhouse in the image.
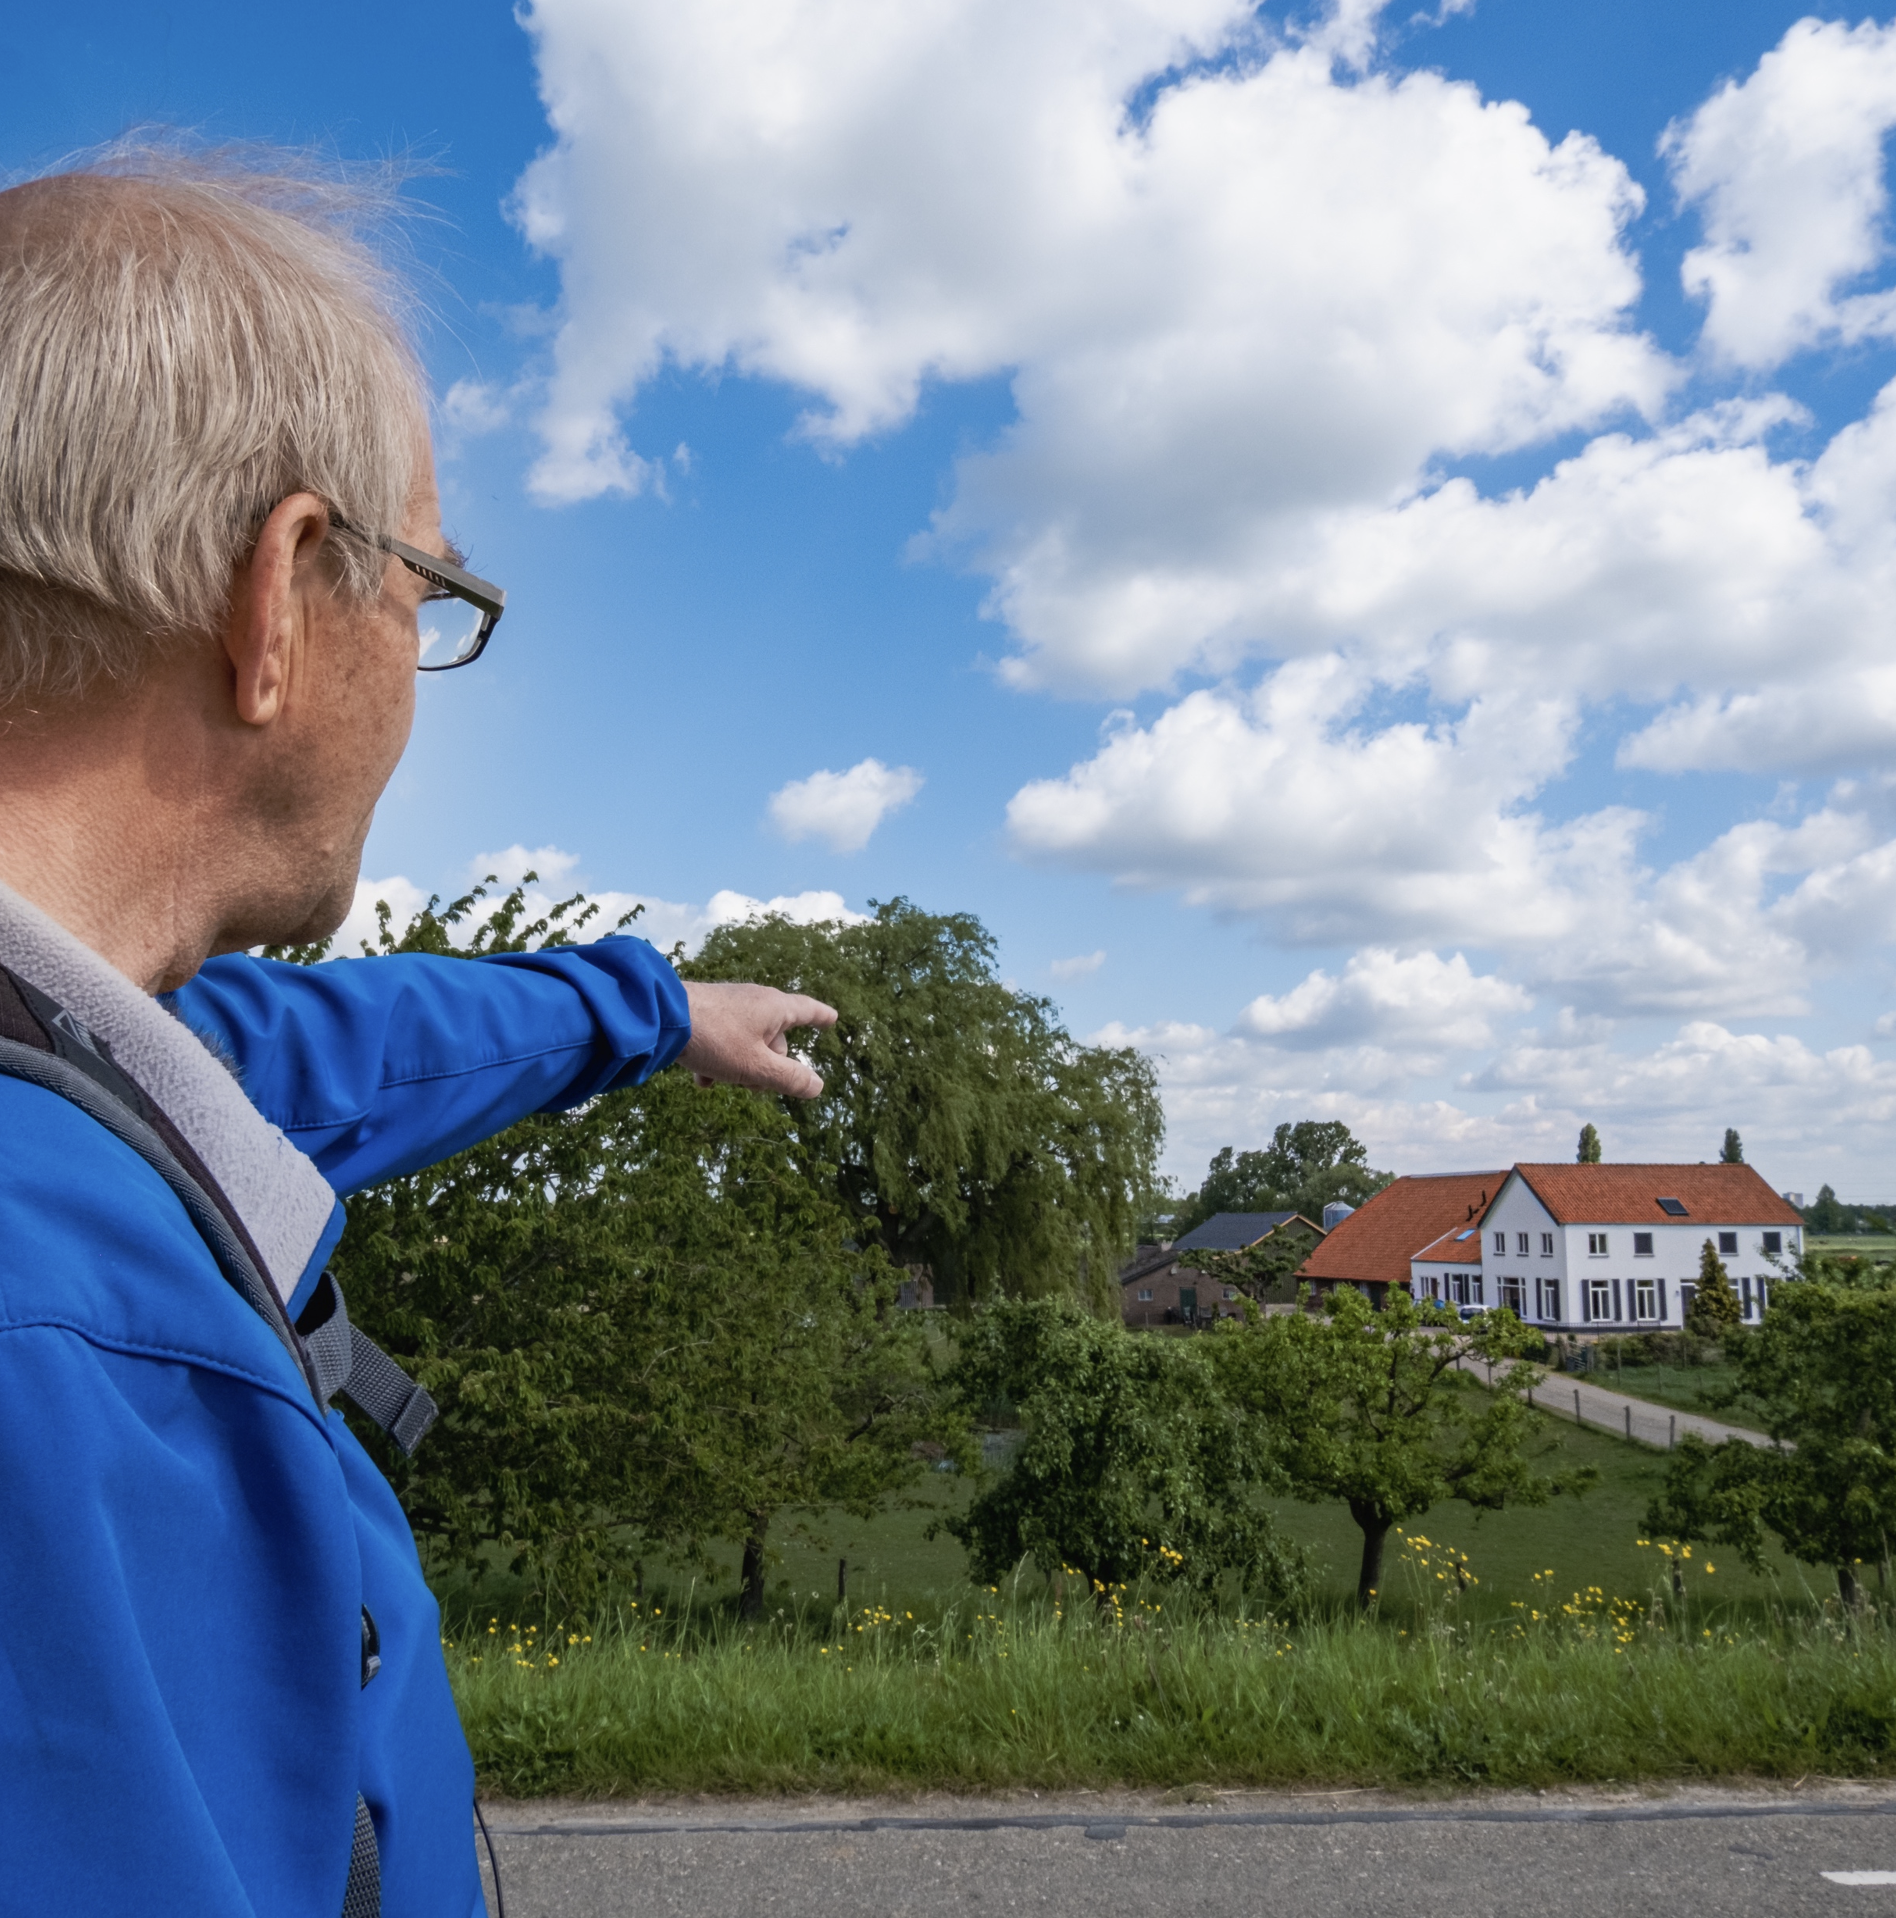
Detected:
[1645,1268,1896,1605]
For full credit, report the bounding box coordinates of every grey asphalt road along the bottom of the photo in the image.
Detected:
[487,1782,1896,1918]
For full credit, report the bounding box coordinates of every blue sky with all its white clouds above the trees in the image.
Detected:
[11,0,1896,1199]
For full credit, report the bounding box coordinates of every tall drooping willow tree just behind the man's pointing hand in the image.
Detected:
[684,900,1164,1312]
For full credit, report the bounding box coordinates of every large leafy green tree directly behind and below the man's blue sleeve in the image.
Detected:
[322,890,968,1613]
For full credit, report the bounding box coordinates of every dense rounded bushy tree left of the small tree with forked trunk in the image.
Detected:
[941,1298,1304,1603]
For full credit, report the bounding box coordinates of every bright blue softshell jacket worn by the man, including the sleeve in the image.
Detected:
[0,938,690,1918]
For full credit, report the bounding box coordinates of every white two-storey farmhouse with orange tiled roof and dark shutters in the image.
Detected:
[1449,1164,1804,1331]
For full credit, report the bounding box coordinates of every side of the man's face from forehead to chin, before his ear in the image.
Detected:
[238,453,447,959]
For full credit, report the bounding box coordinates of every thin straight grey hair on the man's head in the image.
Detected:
[0,142,428,706]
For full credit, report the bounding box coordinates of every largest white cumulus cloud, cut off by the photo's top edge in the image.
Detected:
[520,0,1670,687]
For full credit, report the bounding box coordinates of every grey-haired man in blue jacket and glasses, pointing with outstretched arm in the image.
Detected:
[0,153,834,1918]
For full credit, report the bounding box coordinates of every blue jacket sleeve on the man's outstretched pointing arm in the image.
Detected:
[167,938,690,1193]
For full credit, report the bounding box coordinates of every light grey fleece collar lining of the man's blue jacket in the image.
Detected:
[0,886,335,1304]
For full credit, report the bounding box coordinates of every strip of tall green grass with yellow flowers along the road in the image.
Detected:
[449,1575,1896,1795]
